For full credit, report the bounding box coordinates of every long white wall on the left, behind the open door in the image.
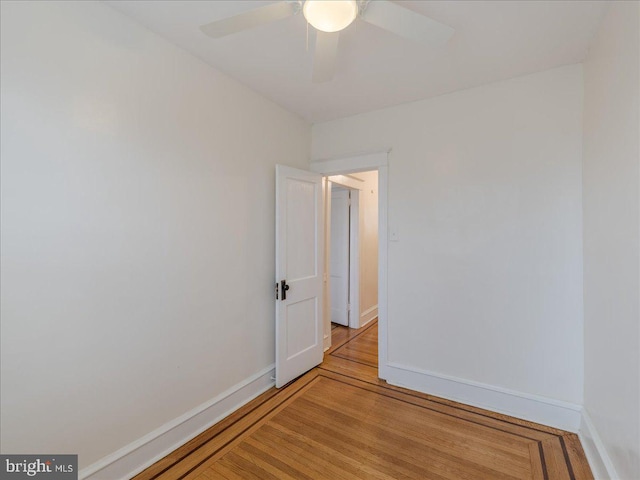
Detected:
[1,1,310,467]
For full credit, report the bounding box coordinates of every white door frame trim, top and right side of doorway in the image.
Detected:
[310,149,391,380]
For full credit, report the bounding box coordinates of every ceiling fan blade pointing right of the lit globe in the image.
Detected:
[360,0,455,45]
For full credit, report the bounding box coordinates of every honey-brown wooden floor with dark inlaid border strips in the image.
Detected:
[135,323,593,480]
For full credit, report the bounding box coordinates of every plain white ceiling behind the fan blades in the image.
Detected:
[106,0,606,123]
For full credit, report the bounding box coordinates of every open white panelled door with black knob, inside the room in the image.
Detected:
[276,165,323,388]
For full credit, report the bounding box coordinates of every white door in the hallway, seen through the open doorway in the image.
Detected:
[329,185,350,327]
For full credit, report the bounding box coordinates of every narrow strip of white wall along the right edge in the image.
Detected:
[583,2,640,480]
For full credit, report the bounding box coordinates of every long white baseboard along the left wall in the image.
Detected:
[79,365,275,480]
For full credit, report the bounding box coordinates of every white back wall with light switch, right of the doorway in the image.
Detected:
[312,65,583,406]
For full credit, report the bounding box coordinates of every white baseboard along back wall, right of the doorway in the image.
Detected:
[385,362,582,433]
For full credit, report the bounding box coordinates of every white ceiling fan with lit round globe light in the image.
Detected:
[200,0,454,83]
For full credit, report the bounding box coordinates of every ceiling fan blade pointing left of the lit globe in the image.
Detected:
[200,1,300,38]
